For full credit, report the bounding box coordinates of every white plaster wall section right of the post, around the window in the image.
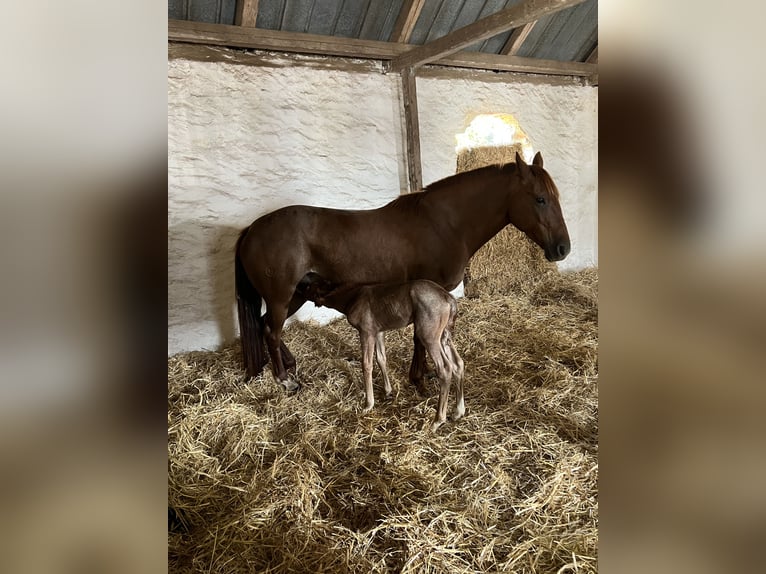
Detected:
[417,76,598,269]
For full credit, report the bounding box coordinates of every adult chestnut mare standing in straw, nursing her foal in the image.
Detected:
[235,152,570,394]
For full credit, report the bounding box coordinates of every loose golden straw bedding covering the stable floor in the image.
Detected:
[168,269,598,573]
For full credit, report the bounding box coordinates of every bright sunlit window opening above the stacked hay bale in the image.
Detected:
[455,114,534,162]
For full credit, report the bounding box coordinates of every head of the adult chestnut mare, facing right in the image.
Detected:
[508,152,570,261]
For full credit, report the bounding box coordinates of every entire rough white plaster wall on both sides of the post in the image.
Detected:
[168,56,597,354]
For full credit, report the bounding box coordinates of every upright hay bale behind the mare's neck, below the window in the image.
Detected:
[457,143,557,297]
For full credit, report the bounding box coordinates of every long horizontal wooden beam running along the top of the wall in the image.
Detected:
[168,20,598,76]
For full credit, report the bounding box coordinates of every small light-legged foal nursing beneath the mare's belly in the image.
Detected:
[298,273,465,431]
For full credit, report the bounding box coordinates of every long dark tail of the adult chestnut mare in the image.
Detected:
[234,227,267,377]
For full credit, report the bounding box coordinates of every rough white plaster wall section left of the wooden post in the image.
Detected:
[168,58,402,354]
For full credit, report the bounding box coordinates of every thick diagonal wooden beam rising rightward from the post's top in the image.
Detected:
[390,0,584,72]
